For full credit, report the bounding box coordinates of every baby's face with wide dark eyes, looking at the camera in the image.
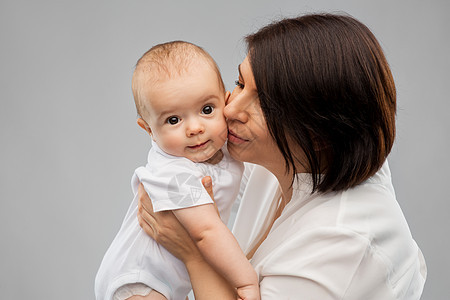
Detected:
[145,63,228,162]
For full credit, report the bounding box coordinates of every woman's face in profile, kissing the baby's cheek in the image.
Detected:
[224,57,284,169]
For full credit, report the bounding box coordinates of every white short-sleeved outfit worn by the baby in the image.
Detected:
[95,143,244,300]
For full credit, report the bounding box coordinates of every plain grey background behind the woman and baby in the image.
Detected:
[0,0,450,300]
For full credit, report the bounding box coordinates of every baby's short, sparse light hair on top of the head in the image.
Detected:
[132,41,225,117]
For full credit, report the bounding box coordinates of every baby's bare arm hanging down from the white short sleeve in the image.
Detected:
[173,204,260,300]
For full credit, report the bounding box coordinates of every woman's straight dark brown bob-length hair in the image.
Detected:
[246,14,396,192]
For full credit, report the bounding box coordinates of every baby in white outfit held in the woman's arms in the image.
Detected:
[95,41,260,300]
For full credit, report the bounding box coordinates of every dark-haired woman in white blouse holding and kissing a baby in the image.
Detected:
[138,14,426,300]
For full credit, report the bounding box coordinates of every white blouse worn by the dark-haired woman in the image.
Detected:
[233,162,426,300]
